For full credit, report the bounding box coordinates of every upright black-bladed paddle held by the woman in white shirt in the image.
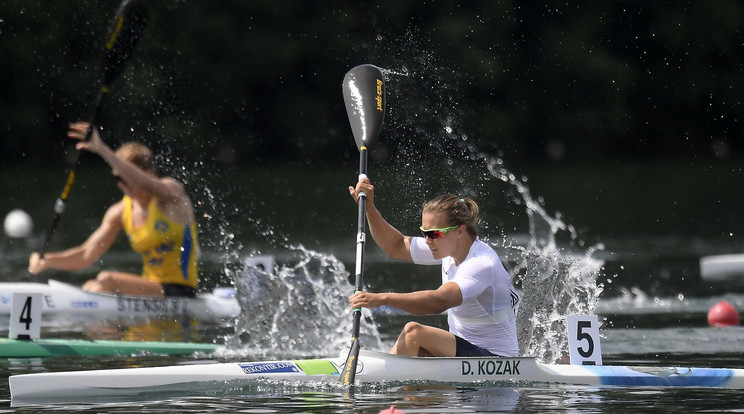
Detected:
[341,64,385,385]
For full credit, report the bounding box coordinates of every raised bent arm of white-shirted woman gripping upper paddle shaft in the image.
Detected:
[349,178,413,262]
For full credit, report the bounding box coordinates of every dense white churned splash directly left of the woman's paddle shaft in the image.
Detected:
[227,246,382,357]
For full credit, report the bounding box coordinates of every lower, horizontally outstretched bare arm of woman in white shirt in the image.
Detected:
[349,282,462,315]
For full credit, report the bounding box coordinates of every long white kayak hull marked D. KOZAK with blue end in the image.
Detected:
[9,351,744,402]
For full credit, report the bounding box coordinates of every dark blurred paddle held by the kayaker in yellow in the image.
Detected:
[39,0,147,258]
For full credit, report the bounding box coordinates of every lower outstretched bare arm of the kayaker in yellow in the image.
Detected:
[28,201,124,274]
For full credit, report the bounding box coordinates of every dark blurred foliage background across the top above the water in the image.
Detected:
[0,0,744,165]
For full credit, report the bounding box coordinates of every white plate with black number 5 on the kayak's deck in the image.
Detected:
[566,315,602,365]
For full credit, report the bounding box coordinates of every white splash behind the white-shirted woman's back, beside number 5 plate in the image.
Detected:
[488,160,604,362]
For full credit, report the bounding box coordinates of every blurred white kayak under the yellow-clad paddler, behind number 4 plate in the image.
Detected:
[0,280,240,320]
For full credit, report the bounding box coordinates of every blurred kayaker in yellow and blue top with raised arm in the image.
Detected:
[28,122,198,297]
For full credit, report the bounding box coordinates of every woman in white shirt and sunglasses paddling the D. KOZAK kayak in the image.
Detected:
[349,178,519,357]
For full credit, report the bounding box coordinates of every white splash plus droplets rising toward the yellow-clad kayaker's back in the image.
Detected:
[159,153,383,358]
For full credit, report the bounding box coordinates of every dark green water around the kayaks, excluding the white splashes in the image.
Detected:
[0,160,744,413]
